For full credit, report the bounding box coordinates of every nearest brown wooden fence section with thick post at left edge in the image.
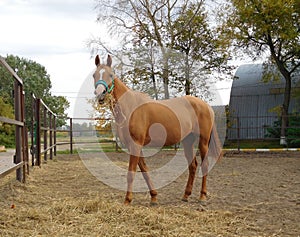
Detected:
[0,56,29,182]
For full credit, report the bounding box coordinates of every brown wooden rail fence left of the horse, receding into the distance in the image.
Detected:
[0,56,117,182]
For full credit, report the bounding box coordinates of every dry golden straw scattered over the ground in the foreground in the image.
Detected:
[0,156,245,237]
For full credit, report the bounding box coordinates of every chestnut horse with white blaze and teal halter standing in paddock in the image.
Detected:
[93,55,222,205]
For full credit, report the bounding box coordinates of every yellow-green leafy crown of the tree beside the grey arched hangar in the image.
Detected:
[221,0,300,61]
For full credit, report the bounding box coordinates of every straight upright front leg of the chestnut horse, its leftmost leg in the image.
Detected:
[124,155,139,205]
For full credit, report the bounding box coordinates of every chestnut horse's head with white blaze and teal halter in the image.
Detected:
[93,55,114,103]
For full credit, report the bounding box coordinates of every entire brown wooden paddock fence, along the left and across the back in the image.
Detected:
[0,56,300,182]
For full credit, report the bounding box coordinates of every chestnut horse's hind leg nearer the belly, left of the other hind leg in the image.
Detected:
[182,134,198,202]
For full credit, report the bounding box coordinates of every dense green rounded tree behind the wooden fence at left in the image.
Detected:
[0,55,69,126]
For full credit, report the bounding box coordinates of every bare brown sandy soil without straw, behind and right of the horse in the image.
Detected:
[102,151,300,236]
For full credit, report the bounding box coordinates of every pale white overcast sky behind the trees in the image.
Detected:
[0,0,230,117]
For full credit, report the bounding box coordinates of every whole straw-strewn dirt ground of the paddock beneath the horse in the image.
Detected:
[0,151,300,236]
